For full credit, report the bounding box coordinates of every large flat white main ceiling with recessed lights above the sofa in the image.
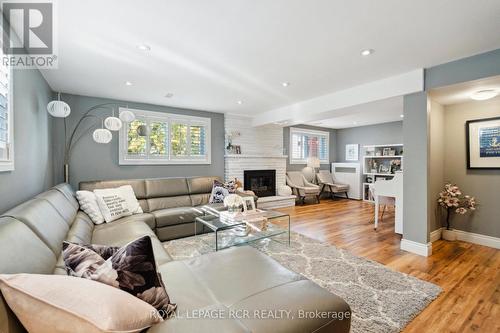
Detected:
[43,0,500,122]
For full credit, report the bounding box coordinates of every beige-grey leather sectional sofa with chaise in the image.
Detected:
[0,177,350,333]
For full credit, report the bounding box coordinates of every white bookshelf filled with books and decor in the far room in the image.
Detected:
[362,143,403,202]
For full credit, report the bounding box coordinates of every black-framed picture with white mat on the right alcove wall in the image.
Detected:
[465,117,500,169]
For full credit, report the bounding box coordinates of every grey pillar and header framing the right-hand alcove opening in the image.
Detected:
[403,49,500,243]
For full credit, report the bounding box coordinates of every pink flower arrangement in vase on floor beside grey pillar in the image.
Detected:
[437,183,477,241]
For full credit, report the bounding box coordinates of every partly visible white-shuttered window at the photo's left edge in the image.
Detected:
[0,45,14,171]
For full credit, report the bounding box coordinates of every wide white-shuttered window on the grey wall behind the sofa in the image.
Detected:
[119,110,211,165]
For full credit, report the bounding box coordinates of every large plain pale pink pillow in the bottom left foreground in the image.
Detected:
[0,274,163,333]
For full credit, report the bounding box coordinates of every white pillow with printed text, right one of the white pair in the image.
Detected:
[94,188,132,223]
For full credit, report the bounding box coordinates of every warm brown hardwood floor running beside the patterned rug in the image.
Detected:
[274,199,500,333]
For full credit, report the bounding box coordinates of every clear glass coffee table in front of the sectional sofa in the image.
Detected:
[194,206,290,251]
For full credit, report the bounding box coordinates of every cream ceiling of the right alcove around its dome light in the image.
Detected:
[429,76,500,105]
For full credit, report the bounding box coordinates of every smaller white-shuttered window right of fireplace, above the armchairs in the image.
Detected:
[290,127,330,164]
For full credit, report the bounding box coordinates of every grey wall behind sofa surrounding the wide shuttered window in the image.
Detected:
[54,95,224,188]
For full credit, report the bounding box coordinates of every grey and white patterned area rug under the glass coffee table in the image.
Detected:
[164,233,441,333]
